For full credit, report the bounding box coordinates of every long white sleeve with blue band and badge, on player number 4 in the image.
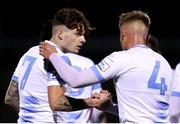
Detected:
[50,53,118,87]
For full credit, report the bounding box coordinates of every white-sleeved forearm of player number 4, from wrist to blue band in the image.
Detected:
[50,53,99,87]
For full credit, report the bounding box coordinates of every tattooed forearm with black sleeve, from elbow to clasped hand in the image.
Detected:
[49,90,110,111]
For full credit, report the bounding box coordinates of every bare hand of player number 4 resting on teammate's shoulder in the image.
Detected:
[39,42,57,59]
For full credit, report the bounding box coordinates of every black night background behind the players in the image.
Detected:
[0,0,180,122]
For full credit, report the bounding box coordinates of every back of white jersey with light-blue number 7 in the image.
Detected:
[13,46,54,123]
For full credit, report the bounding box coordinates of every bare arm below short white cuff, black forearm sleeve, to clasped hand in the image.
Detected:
[48,85,111,111]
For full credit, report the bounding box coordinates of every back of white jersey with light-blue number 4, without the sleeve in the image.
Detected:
[113,46,172,123]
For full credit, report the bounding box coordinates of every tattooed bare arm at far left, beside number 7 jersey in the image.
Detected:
[4,79,19,112]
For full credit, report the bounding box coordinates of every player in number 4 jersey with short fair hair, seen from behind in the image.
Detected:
[40,11,172,123]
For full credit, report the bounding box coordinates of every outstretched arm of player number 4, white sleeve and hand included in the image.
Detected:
[39,42,117,87]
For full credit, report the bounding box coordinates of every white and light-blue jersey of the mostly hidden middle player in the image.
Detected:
[48,53,101,123]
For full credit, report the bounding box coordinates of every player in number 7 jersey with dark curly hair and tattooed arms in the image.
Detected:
[5,8,109,123]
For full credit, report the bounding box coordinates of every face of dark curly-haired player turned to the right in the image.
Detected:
[63,29,86,53]
